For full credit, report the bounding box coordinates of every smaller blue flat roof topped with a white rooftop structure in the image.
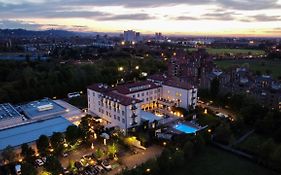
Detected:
[20,98,66,118]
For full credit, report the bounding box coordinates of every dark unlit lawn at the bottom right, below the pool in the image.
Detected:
[174,147,277,175]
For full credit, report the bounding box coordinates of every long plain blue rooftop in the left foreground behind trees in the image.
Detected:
[0,117,72,150]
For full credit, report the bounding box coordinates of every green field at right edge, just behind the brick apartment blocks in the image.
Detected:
[215,59,281,78]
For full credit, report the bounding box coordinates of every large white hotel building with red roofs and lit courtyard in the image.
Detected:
[87,78,197,132]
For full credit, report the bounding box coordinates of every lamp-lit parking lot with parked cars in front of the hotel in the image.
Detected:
[57,143,163,175]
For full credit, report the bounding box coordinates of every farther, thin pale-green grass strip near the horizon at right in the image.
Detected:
[188,48,265,56]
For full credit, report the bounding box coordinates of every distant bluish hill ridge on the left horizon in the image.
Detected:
[0,29,97,38]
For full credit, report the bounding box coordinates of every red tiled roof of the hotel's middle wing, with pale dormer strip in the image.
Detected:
[115,81,161,94]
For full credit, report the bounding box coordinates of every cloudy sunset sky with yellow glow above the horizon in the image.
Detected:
[0,0,281,36]
